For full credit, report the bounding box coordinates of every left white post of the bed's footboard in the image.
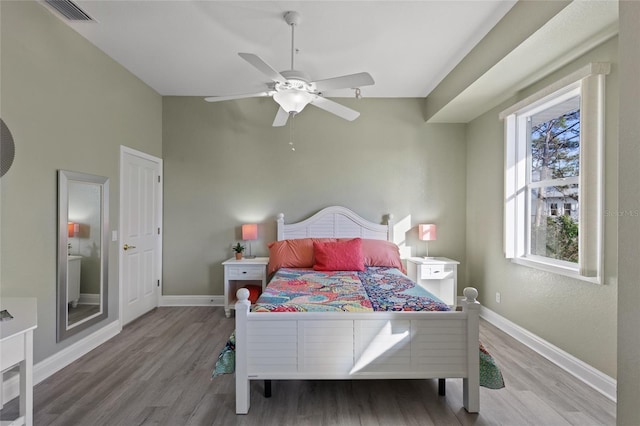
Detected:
[236,288,251,414]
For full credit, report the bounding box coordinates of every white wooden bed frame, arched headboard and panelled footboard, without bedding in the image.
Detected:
[235,206,480,414]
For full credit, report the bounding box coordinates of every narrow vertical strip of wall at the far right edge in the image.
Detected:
[617,1,640,425]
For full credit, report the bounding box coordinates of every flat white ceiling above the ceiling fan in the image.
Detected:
[46,0,515,97]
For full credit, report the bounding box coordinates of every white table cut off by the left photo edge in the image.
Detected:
[0,297,38,426]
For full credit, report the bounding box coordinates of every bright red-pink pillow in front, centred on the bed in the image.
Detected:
[313,238,364,271]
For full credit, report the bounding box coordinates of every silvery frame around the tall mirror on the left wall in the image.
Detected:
[56,170,109,342]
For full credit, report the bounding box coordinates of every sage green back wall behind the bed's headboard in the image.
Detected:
[162,97,466,295]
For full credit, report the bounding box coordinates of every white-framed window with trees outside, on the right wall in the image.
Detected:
[500,63,610,283]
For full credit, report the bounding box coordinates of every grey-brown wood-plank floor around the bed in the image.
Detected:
[1,307,615,426]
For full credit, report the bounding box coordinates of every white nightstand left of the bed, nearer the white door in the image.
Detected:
[222,257,269,318]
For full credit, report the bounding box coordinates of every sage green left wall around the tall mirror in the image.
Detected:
[0,1,162,363]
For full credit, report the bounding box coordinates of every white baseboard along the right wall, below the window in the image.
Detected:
[480,306,617,402]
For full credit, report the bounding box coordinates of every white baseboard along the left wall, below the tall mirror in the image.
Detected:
[2,320,122,404]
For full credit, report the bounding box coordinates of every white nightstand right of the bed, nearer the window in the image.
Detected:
[407,257,460,306]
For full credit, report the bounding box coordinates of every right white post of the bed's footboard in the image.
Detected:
[462,287,480,413]
